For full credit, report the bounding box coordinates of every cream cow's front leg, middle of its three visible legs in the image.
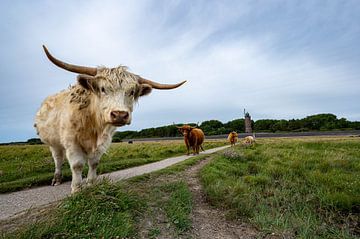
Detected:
[66,146,85,193]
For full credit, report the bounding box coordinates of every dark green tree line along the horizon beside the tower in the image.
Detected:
[113,114,360,142]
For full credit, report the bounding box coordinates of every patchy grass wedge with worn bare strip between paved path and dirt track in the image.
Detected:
[0,151,205,239]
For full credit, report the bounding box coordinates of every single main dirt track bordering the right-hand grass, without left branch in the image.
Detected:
[184,158,257,239]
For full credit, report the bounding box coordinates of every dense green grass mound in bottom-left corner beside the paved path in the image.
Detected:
[2,182,146,239]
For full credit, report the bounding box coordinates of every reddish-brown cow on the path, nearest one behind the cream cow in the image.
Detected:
[177,125,205,155]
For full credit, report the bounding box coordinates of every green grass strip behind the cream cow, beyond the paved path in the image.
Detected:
[0,140,226,193]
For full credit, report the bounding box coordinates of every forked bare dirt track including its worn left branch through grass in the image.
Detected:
[139,156,259,239]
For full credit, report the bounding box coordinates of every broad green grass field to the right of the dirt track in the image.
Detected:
[201,138,360,238]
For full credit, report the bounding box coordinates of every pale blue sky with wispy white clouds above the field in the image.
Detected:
[0,0,360,142]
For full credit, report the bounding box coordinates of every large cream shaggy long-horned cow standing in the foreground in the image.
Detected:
[34,46,185,192]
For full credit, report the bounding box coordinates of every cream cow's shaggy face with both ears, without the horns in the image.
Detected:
[78,71,152,126]
